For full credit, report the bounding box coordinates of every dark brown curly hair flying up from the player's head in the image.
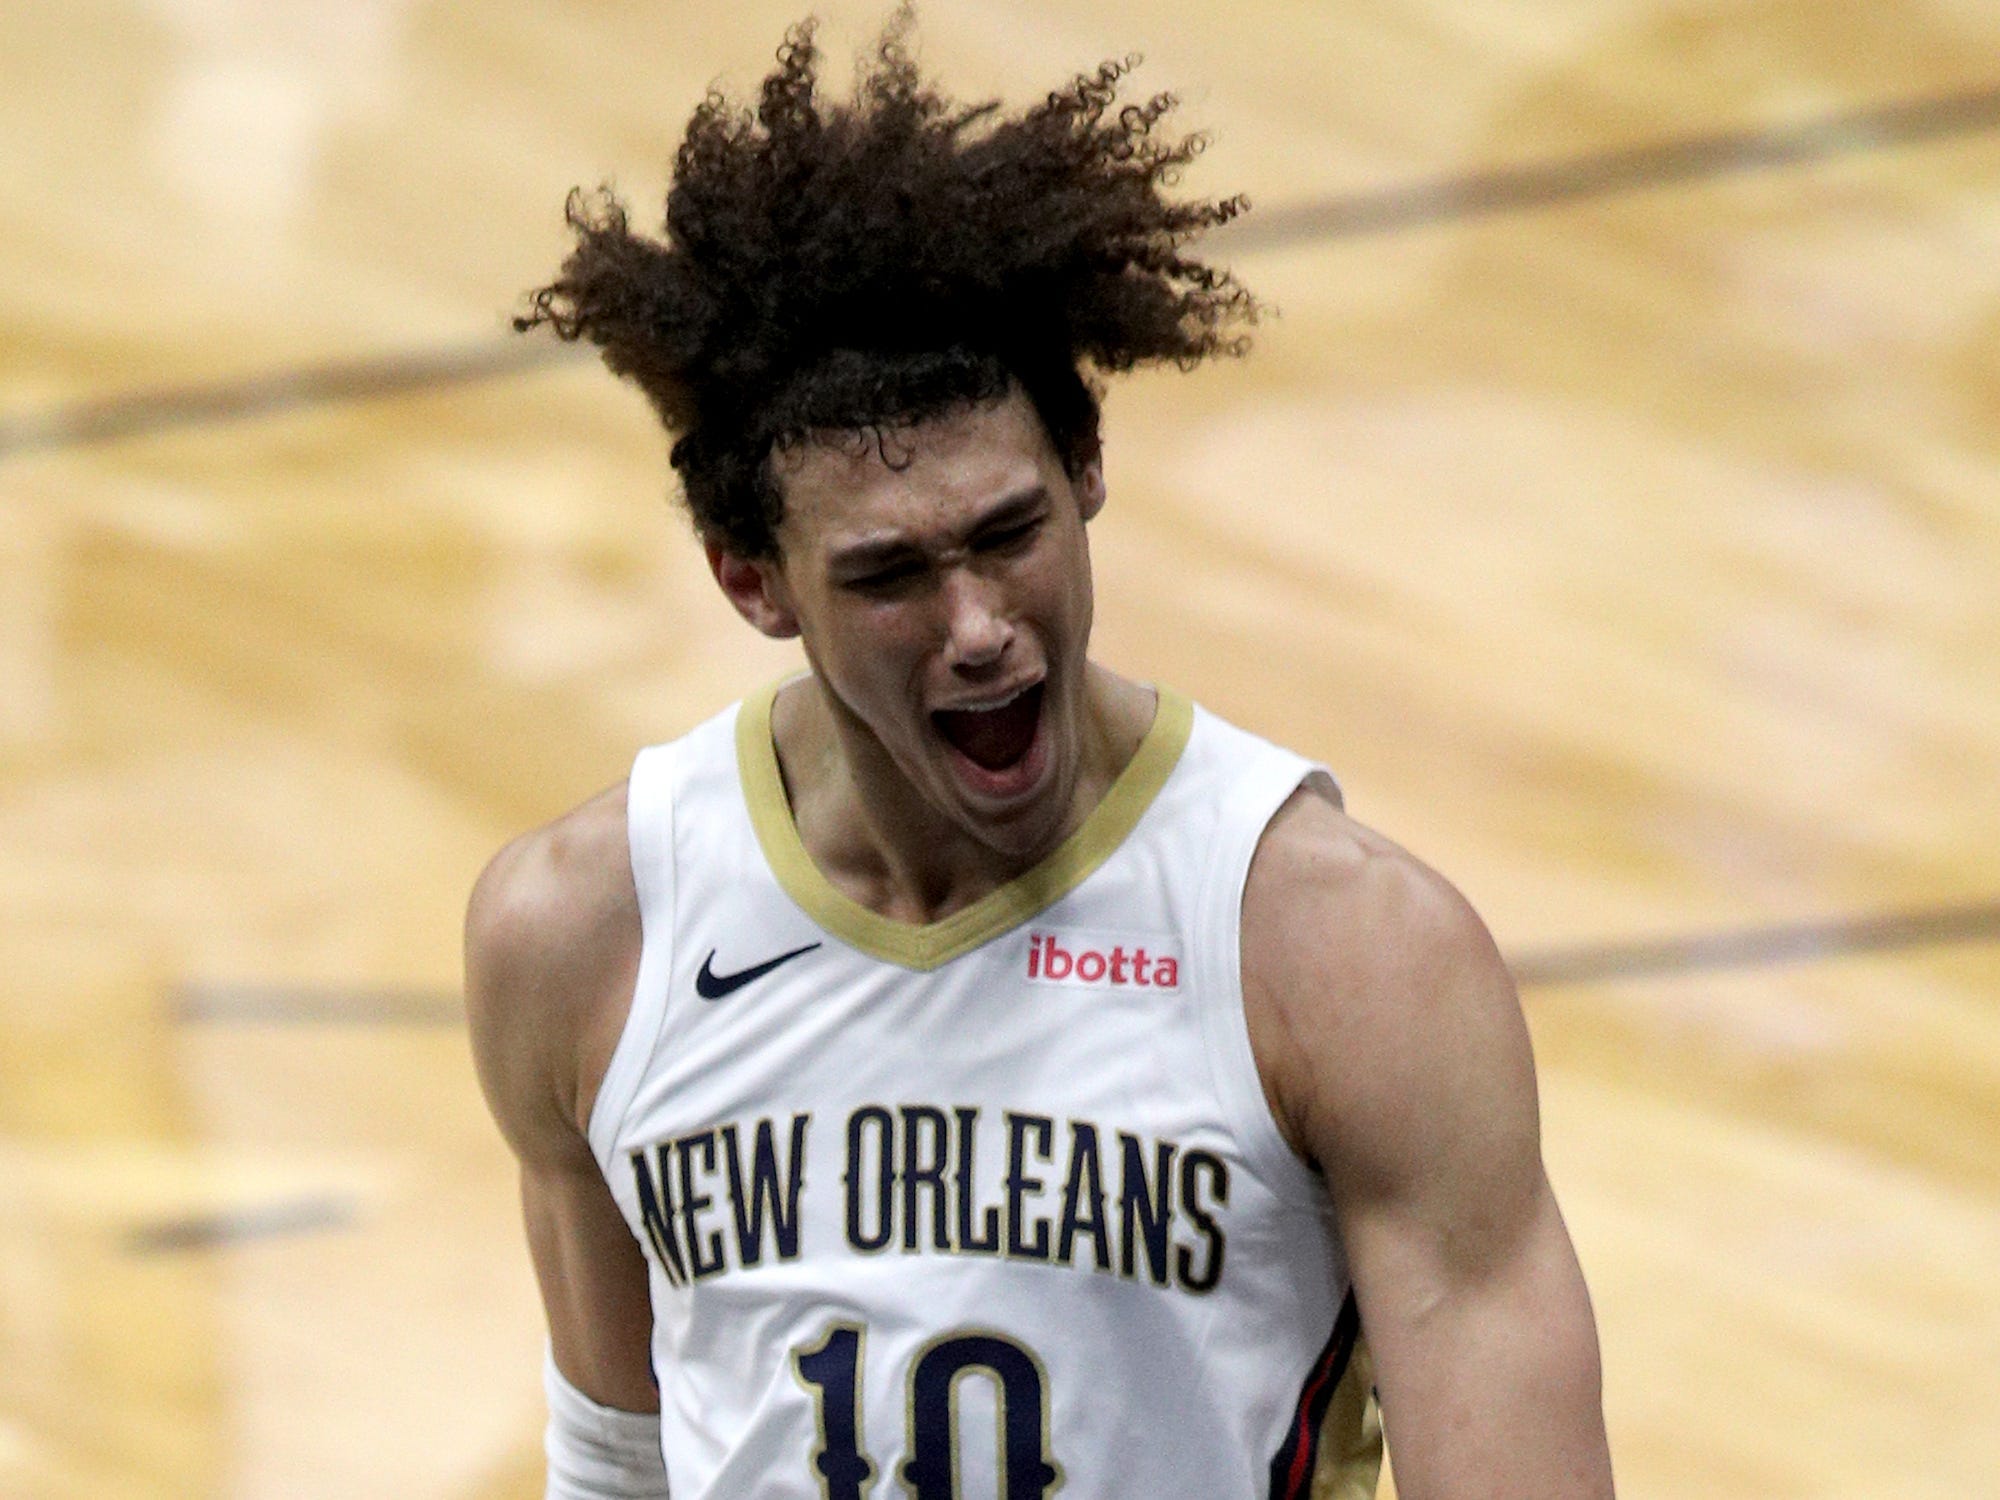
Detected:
[514,8,1258,558]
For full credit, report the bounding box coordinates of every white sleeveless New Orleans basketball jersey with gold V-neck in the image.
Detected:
[590,690,1380,1500]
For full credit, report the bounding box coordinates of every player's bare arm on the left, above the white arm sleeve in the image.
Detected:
[466,786,660,1412]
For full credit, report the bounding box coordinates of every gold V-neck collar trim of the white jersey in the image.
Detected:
[736,682,1194,972]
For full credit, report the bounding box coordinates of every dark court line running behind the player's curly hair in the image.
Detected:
[0,86,2000,458]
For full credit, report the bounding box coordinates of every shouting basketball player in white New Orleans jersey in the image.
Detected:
[466,14,1610,1500]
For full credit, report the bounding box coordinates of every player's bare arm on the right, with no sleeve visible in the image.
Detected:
[1244,792,1612,1500]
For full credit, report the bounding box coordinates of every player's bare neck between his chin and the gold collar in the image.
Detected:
[772,666,1154,924]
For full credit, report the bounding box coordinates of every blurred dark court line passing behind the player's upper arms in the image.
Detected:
[174,900,2000,1026]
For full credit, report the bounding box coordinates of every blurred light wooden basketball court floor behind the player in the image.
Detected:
[0,0,2000,1500]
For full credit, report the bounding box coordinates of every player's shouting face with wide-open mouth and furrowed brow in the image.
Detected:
[718,392,1104,856]
